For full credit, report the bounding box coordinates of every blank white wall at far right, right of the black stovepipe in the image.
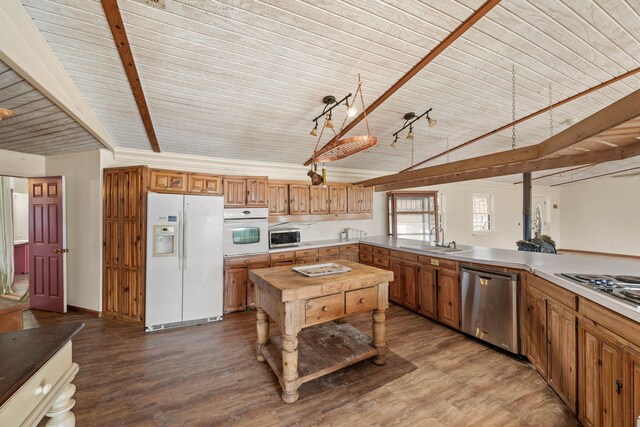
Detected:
[560,176,640,255]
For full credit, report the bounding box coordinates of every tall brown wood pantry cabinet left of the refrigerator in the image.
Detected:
[102,166,149,325]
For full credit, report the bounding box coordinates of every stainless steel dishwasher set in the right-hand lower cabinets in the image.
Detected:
[460,267,520,354]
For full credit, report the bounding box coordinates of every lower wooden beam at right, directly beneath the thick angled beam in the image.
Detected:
[375,142,640,192]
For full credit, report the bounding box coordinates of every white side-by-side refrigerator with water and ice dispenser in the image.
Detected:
[145,193,224,331]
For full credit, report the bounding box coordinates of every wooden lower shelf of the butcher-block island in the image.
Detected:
[262,322,378,383]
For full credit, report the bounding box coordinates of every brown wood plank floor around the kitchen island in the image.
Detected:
[25,305,578,427]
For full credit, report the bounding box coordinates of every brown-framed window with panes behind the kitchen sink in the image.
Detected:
[387,191,438,241]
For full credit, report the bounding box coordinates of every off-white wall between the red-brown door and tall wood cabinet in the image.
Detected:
[46,150,102,311]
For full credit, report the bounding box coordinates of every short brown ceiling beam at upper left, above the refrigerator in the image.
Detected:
[101,0,160,153]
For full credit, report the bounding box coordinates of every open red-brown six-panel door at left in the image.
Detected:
[29,177,68,313]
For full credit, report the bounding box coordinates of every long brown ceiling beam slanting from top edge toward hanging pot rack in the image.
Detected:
[302,0,500,166]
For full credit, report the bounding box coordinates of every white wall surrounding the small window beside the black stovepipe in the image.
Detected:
[404,180,560,249]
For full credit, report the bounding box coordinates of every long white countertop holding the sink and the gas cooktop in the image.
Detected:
[360,236,640,322]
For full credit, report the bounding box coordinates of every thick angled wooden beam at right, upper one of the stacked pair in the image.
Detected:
[357,90,640,187]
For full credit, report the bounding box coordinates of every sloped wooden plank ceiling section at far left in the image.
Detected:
[0,61,103,155]
